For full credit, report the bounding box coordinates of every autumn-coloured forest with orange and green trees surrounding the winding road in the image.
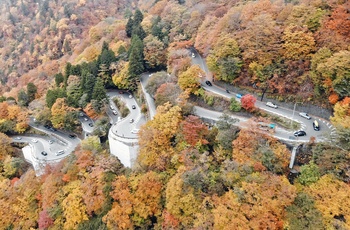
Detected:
[0,0,350,230]
